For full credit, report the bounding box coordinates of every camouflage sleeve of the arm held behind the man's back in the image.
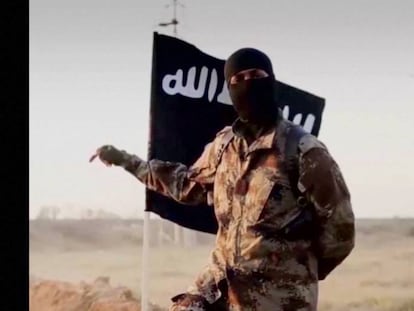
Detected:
[298,136,355,280]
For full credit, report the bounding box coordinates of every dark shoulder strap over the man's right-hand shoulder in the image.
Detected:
[284,124,308,198]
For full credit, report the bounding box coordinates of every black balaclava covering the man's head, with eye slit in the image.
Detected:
[224,48,278,125]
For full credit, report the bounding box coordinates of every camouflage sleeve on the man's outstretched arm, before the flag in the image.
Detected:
[122,131,230,205]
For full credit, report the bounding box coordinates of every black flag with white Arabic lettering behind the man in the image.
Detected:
[146,32,325,234]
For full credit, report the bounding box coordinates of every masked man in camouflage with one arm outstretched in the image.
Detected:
[90,48,355,311]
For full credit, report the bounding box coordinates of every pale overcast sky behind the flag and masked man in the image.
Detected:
[30,0,414,217]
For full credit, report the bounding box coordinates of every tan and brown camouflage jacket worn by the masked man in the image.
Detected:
[124,118,354,311]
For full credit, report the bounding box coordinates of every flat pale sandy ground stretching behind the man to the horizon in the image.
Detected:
[30,219,414,311]
